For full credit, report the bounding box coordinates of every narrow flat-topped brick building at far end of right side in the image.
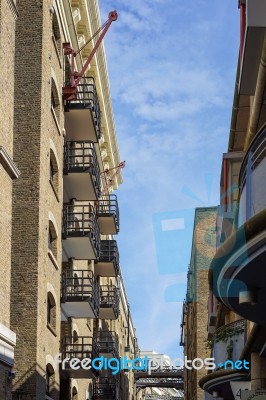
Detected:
[181,207,217,400]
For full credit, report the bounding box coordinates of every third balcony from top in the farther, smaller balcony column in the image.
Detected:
[99,285,119,319]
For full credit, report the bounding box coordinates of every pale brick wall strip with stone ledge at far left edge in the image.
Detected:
[0,0,20,400]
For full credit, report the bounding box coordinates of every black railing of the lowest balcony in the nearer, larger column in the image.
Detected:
[61,336,99,360]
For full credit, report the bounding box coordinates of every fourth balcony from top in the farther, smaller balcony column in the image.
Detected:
[94,331,118,358]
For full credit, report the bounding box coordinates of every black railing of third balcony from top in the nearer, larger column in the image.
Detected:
[62,204,100,258]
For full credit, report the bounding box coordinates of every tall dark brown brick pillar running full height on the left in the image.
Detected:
[11,0,45,399]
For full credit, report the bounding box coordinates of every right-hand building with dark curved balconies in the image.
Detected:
[199,0,266,400]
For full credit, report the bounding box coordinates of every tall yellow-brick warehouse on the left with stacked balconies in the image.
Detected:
[0,0,137,400]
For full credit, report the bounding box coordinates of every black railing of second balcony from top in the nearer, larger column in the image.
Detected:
[64,141,101,196]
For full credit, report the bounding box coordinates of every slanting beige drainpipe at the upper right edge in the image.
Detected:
[244,35,266,151]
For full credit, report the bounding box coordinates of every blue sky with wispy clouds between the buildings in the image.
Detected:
[99,0,239,357]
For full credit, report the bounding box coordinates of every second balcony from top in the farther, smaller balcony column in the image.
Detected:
[94,240,120,277]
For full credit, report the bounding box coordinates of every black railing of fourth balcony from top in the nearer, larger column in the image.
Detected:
[61,270,100,315]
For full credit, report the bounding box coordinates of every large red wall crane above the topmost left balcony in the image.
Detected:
[63,11,118,101]
